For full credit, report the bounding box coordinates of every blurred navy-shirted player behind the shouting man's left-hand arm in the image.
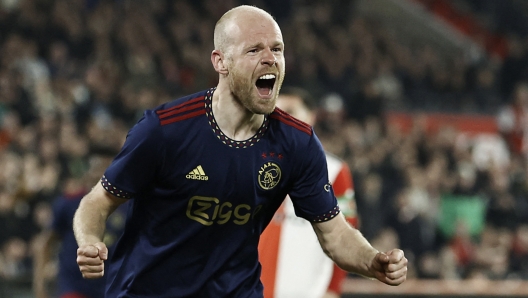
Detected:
[33,156,128,298]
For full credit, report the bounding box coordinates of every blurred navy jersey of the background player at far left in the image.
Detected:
[52,192,128,298]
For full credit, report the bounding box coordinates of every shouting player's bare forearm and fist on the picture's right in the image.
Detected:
[312,214,407,285]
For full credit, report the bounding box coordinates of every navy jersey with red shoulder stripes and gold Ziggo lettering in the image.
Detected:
[101,88,339,298]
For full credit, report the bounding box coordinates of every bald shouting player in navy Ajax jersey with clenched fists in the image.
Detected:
[74,6,407,298]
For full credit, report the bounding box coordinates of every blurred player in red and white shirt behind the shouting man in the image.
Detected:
[259,86,357,298]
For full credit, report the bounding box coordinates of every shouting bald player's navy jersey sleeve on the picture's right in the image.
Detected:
[289,134,340,222]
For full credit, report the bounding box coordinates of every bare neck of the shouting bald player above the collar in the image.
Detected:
[212,83,264,141]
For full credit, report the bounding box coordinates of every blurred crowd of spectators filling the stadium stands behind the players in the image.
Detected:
[0,0,528,294]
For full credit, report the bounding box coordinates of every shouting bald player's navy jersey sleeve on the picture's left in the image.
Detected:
[101,111,164,199]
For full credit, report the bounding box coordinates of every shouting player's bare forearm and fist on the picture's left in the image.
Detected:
[73,183,127,278]
